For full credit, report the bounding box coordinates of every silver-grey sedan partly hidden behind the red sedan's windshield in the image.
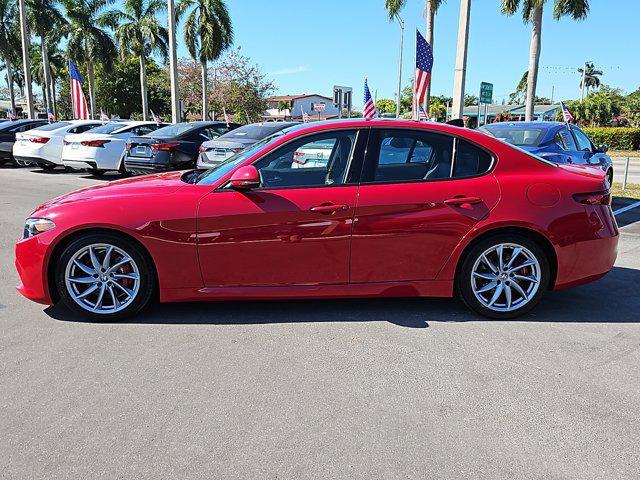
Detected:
[198,122,300,168]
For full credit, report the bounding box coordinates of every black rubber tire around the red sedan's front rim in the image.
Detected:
[55,233,156,321]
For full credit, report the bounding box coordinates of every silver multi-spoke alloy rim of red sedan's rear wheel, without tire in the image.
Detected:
[471,243,542,312]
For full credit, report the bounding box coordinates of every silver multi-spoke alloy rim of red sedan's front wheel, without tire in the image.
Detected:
[64,243,140,314]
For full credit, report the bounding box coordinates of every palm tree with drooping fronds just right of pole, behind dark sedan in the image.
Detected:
[176,0,233,120]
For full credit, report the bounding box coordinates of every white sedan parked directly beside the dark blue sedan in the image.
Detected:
[62,121,166,175]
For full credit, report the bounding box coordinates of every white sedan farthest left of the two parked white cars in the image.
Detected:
[13,120,101,170]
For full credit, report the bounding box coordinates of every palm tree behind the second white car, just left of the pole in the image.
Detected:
[115,0,169,120]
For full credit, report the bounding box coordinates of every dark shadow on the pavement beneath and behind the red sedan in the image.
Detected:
[45,267,640,328]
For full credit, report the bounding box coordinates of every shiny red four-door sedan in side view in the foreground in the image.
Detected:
[16,120,618,320]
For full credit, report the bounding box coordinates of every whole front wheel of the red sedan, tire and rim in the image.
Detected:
[55,234,154,321]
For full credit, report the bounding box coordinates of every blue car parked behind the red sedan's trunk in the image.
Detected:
[479,122,613,185]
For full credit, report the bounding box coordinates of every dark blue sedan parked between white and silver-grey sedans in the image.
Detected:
[124,121,240,174]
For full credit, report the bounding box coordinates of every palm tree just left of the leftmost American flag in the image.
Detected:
[26,0,66,117]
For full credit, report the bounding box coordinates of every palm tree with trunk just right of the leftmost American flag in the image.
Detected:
[61,0,118,118]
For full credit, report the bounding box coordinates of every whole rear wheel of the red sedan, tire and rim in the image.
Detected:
[458,234,549,319]
